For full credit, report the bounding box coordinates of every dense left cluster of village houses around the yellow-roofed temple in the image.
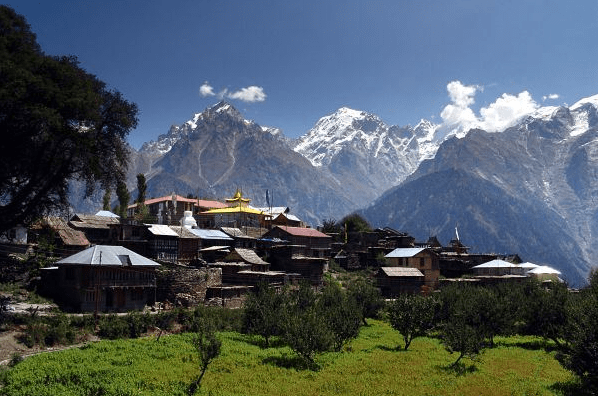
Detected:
[1,190,332,311]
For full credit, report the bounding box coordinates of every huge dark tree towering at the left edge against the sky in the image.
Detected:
[0,6,138,231]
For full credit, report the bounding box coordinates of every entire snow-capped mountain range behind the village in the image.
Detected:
[71,95,598,284]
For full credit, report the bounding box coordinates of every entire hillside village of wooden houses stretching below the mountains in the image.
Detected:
[1,189,562,312]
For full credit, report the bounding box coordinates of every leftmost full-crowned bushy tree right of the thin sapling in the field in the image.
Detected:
[243,282,285,347]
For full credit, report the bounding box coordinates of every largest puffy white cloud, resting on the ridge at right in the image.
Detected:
[440,81,539,136]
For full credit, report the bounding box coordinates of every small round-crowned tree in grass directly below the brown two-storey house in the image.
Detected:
[388,295,436,350]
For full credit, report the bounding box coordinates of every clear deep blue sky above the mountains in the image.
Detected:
[5,0,598,148]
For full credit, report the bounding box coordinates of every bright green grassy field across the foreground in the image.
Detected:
[0,320,575,396]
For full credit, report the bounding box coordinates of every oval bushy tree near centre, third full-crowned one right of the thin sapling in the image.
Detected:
[317,282,361,352]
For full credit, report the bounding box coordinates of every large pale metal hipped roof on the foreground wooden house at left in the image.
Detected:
[56,245,160,267]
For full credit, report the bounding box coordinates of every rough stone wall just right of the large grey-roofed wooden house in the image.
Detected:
[156,265,222,307]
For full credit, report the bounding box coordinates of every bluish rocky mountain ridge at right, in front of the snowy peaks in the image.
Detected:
[363,96,598,284]
